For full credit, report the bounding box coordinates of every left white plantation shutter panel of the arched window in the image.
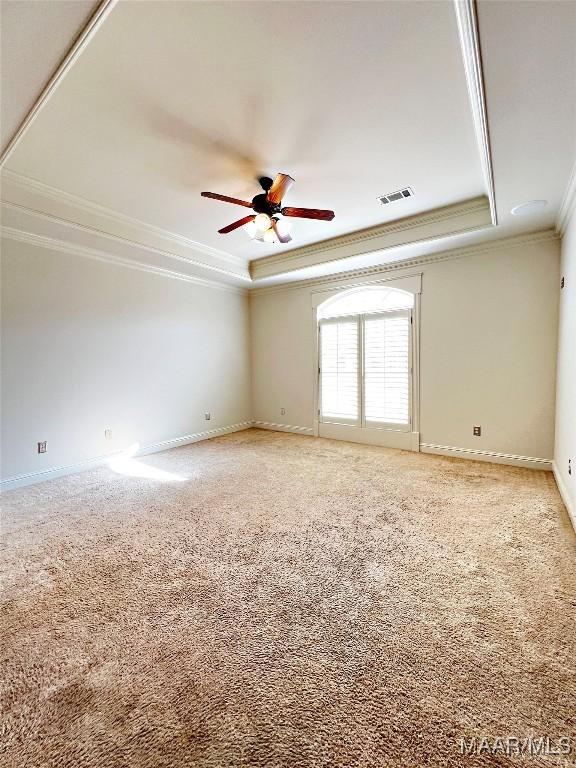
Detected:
[320,317,360,424]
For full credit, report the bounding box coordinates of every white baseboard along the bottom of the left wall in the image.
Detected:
[0,421,252,491]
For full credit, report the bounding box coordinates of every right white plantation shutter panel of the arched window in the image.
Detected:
[364,311,410,427]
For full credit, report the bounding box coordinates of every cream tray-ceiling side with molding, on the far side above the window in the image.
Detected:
[250,197,491,280]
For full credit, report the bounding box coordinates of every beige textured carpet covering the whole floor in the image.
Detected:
[0,430,576,768]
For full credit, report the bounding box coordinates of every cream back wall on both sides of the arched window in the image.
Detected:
[251,234,560,459]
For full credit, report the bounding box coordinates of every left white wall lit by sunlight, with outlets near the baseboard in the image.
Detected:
[2,240,251,478]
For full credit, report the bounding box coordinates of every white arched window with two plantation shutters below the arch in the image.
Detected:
[317,286,414,439]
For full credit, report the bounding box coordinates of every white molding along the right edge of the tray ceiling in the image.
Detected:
[454,0,498,226]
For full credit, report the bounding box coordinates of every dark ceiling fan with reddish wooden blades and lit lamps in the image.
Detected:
[201,173,334,243]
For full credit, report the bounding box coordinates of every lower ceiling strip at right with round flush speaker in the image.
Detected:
[478,0,576,235]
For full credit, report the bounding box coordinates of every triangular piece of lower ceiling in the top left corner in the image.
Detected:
[0,0,99,152]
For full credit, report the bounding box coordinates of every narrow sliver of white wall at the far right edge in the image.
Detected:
[554,211,576,526]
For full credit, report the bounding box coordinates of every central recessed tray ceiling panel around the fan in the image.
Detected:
[2,1,485,259]
